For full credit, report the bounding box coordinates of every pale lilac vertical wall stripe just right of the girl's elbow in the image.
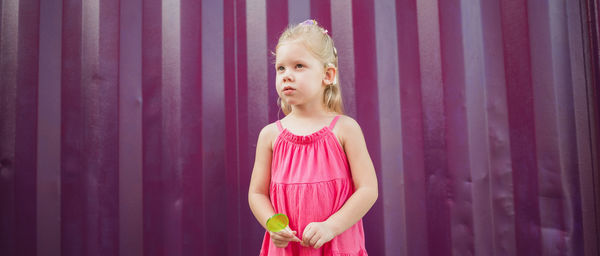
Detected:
[374,0,407,255]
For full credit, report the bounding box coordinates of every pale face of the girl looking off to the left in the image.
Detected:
[275,42,325,109]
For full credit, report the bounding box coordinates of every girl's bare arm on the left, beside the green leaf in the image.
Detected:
[248,125,275,229]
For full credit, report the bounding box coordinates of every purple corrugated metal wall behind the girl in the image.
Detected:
[0,0,600,256]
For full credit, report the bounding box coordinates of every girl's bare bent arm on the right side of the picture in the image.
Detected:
[325,116,378,236]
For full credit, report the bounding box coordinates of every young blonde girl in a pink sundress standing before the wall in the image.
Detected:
[248,20,377,256]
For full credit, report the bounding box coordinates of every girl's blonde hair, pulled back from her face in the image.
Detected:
[275,20,344,115]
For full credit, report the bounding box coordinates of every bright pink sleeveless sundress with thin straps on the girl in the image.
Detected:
[260,116,367,256]
